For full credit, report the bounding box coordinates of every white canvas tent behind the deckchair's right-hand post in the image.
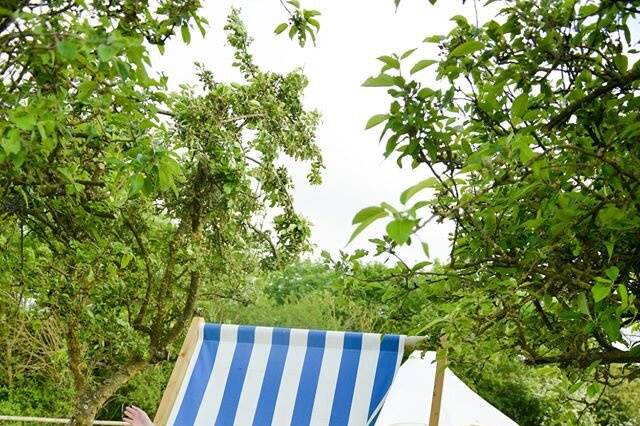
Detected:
[376,351,518,426]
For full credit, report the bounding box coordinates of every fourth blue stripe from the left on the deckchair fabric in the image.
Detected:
[291,330,326,426]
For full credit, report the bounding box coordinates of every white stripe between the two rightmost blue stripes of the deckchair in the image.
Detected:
[349,334,382,426]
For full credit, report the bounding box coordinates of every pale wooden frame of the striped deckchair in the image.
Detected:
[153,317,444,426]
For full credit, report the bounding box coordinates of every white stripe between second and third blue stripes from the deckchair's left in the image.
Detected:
[234,327,273,425]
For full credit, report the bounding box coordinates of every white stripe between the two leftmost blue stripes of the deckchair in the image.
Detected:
[194,325,238,426]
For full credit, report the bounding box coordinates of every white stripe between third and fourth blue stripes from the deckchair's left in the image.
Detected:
[271,329,309,426]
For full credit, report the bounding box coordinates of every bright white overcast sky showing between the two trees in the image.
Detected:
[154,0,498,261]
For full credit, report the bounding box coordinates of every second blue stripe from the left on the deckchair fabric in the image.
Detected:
[215,326,256,426]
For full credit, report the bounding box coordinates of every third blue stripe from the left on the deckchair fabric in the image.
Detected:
[253,328,291,426]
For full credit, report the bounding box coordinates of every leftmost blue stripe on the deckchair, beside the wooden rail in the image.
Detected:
[174,324,220,426]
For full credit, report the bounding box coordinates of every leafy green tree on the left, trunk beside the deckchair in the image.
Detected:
[0,0,321,425]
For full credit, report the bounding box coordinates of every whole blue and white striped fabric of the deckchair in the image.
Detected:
[168,324,405,426]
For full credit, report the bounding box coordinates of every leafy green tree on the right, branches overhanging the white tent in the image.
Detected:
[354,0,640,386]
